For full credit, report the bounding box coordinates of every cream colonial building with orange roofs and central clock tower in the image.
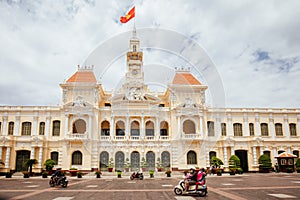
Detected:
[0,34,300,172]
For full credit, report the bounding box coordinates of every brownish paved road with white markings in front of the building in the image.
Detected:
[0,173,300,200]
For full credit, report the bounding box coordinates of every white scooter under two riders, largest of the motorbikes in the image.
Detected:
[174,179,207,197]
